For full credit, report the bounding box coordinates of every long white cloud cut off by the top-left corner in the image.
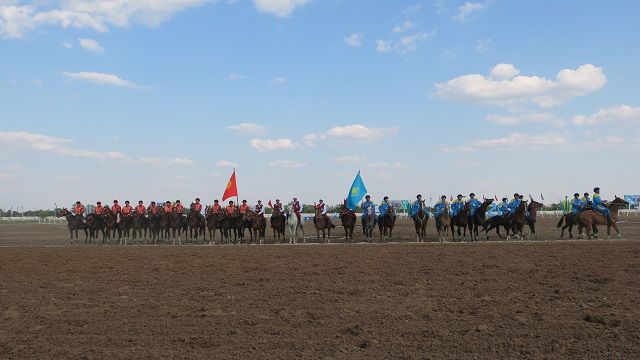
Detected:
[0,0,211,38]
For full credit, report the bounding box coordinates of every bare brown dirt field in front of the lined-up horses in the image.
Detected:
[0,217,640,359]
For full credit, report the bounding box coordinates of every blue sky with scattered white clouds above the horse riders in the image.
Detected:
[0,0,640,210]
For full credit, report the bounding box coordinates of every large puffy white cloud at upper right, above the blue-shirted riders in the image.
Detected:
[435,64,607,108]
